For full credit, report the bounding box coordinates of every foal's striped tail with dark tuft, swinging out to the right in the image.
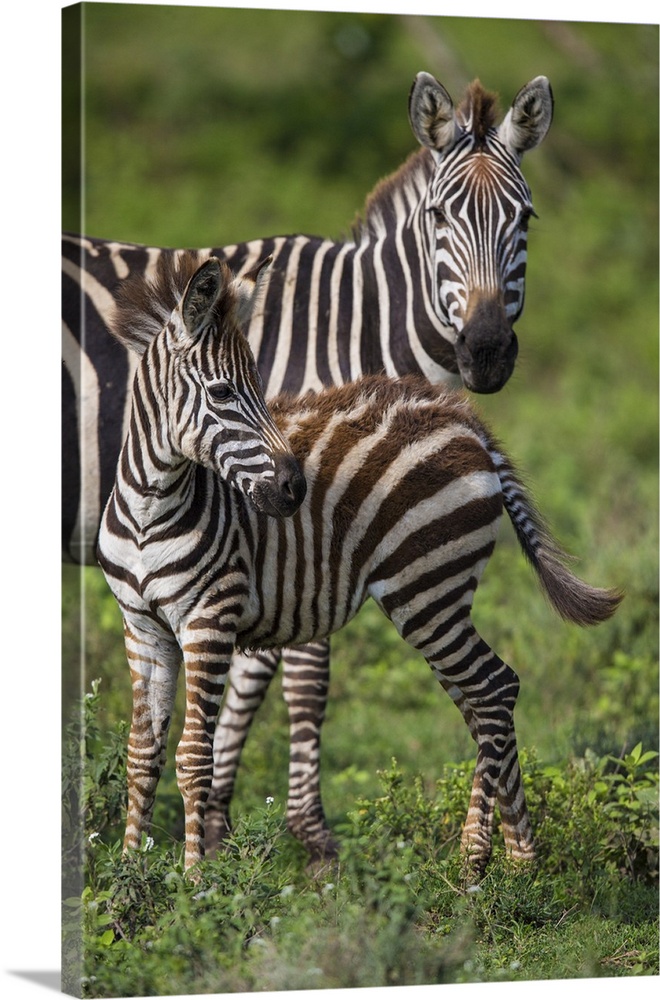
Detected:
[489,440,623,626]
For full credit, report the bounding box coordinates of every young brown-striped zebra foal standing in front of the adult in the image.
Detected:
[99,254,620,872]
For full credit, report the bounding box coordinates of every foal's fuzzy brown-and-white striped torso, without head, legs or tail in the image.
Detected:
[100,376,502,649]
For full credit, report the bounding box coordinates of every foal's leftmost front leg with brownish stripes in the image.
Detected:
[124,620,181,849]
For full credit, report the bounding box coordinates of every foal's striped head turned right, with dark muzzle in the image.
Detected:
[164,257,307,517]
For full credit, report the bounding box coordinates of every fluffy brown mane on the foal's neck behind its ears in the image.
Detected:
[110,250,208,354]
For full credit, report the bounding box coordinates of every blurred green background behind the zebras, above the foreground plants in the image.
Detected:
[63,4,658,840]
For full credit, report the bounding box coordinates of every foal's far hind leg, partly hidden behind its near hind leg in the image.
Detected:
[440,679,535,862]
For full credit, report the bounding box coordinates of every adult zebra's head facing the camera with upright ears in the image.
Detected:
[409,73,553,392]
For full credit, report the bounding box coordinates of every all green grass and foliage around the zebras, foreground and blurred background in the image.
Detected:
[63,4,658,996]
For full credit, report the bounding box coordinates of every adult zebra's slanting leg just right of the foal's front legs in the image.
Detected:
[206,649,280,857]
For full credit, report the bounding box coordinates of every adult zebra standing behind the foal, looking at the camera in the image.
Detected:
[63,73,553,856]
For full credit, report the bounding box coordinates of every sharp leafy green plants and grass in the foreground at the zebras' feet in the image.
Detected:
[64,690,658,997]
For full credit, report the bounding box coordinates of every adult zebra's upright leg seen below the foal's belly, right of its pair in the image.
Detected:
[282,640,339,867]
